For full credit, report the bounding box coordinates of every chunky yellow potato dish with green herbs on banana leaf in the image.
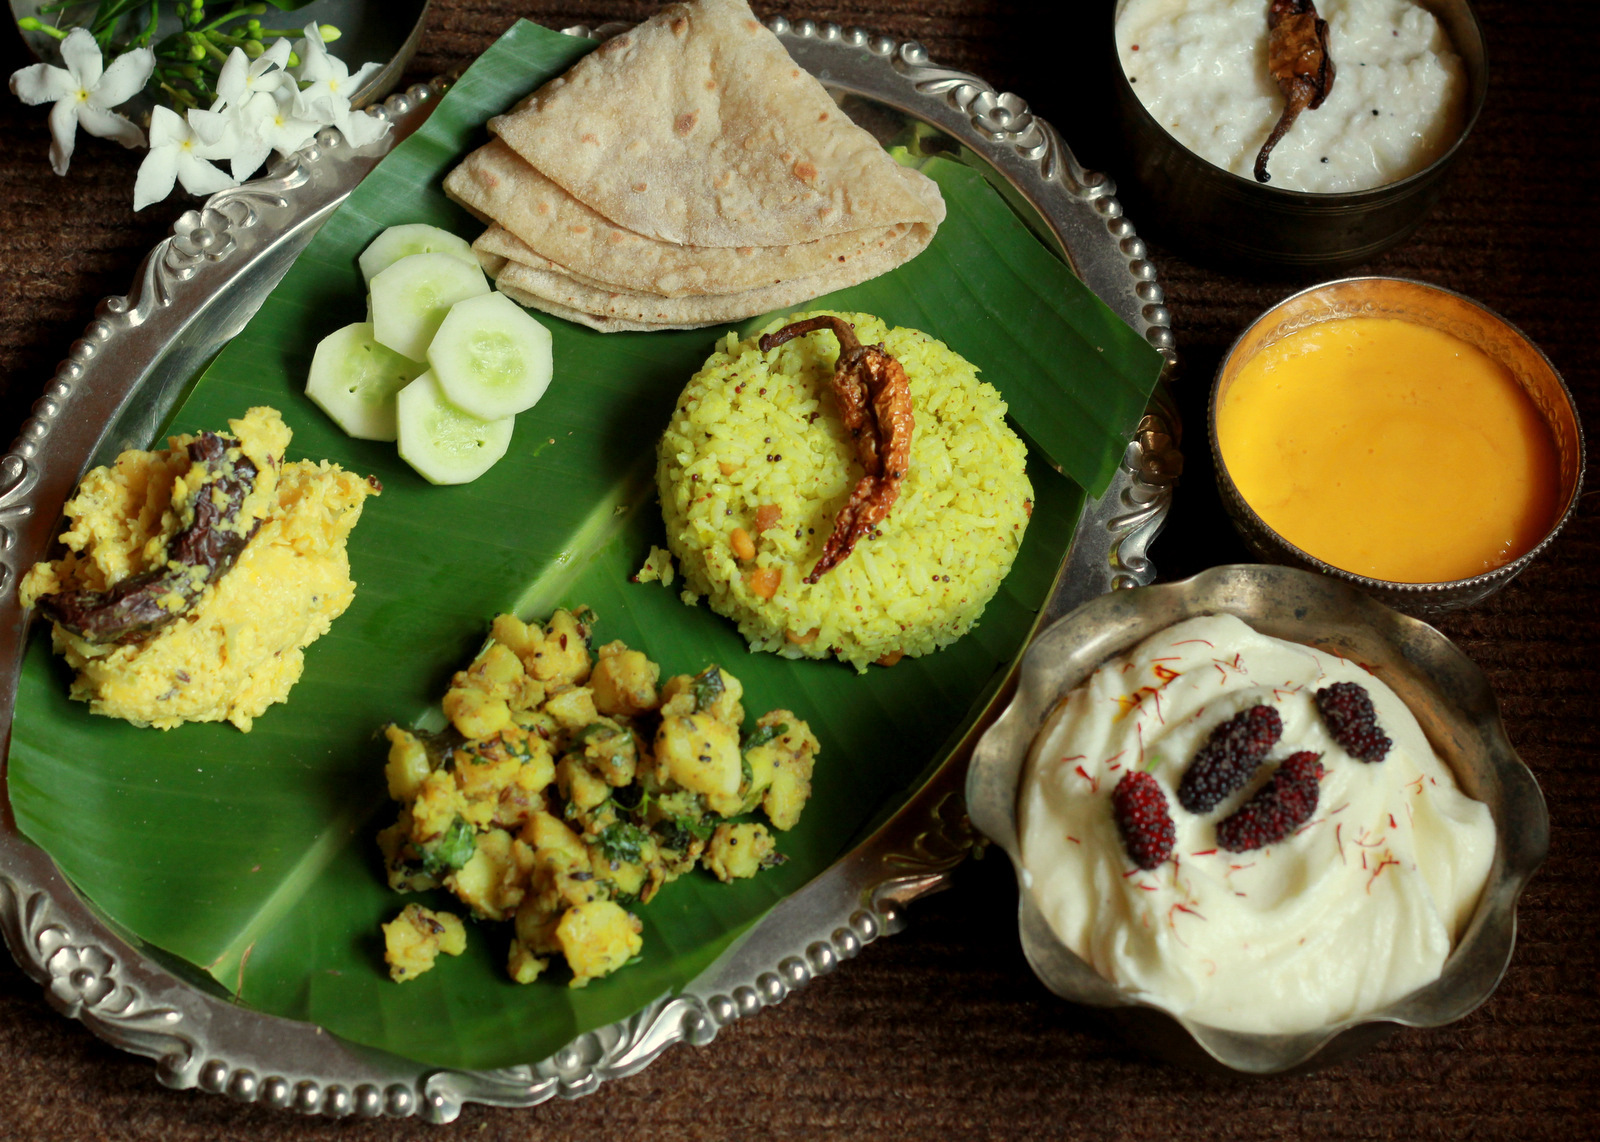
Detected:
[378,611,818,987]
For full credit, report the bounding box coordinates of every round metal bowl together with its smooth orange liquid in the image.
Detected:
[1210,278,1584,616]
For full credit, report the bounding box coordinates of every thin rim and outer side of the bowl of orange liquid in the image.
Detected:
[1206,274,1587,609]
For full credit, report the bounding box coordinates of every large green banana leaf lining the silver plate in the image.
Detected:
[10,24,1160,1068]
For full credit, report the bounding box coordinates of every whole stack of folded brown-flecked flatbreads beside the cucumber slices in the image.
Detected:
[445,0,944,331]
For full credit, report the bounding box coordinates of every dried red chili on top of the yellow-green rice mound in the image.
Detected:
[762,313,914,582]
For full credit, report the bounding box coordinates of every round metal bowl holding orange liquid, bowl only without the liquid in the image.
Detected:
[1208,277,1586,617]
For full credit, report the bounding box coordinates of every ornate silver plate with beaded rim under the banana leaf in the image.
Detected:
[0,18,1181,1121]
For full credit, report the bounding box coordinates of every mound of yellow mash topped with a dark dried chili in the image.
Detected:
[21,408,381,733]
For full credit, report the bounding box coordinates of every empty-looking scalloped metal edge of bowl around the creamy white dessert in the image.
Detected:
[966,565,1550,1075]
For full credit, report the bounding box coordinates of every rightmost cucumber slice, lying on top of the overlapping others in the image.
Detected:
[427,293,550,421]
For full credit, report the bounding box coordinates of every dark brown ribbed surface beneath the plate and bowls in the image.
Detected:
[0,0,1600,1142]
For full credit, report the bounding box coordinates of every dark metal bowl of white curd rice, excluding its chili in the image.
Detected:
[1110,0,1488,277]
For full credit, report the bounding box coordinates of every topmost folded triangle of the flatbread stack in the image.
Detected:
[490,0,944,248]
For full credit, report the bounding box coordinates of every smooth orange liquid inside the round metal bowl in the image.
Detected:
[1216,317,1558,582]
